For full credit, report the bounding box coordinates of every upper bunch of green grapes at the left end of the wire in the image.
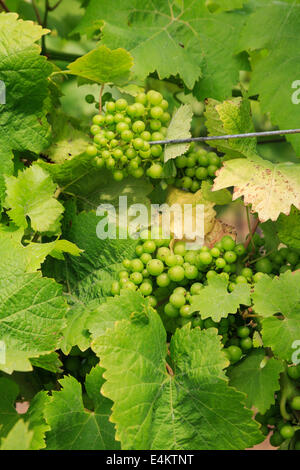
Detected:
[86,90,171,181]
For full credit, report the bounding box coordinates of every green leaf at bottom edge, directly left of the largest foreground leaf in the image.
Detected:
[45,366,119,450]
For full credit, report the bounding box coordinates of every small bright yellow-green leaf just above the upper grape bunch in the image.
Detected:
[68,45,133,84]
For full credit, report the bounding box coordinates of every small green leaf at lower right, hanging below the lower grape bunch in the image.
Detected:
[229,349,284,414]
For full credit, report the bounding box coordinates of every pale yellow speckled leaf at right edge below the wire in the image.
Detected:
[213,155,300,222]
